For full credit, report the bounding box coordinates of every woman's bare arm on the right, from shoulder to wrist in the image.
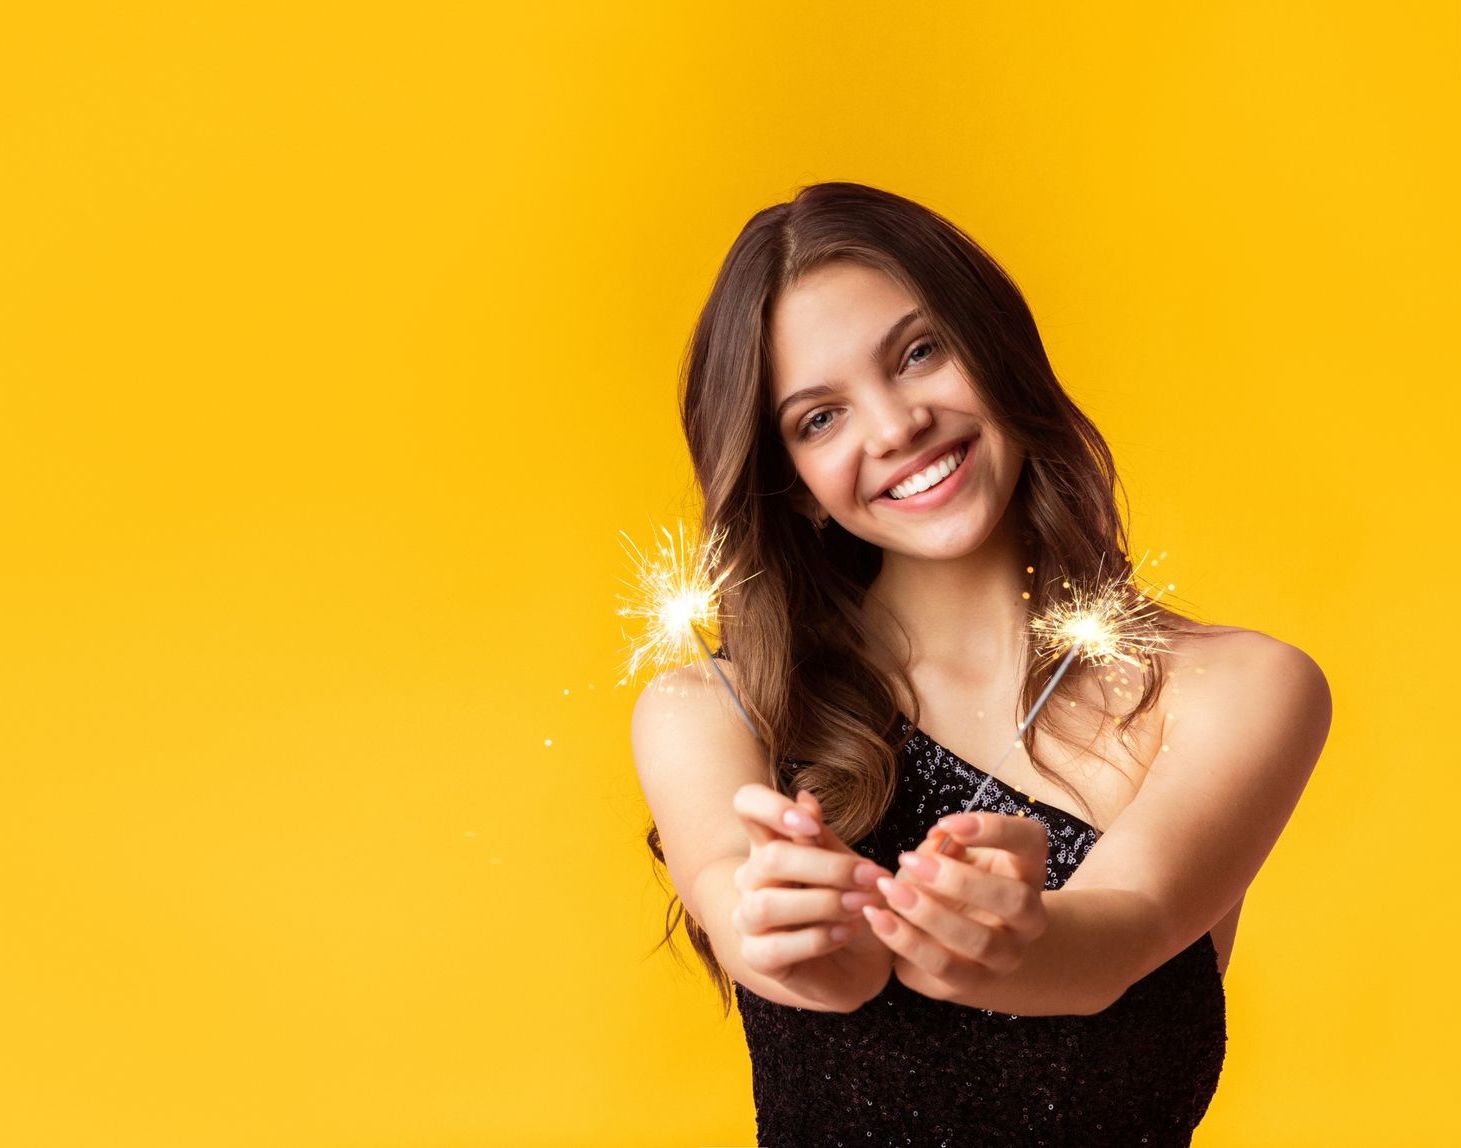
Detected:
[894,632,1331,1015]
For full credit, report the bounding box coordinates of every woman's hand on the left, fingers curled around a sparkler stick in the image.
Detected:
[731,783,894,1000]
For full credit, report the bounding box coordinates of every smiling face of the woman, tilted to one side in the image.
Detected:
[770,261,1024,558]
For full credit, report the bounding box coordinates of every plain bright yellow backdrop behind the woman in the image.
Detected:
[0,0,1461,1148]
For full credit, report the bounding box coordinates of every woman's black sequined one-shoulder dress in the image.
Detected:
[716,650,1227,1148]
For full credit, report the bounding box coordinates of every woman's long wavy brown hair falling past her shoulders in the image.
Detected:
[646,183,1198,1015]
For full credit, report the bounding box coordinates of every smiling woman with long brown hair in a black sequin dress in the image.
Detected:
[633,183,1330,1145]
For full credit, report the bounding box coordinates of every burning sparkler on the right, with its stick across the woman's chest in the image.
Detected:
[935,555,1169,852]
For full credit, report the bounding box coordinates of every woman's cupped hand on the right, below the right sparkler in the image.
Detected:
[862,814,1050,1000]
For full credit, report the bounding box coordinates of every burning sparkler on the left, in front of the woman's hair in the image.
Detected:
[617,523,760,741]
